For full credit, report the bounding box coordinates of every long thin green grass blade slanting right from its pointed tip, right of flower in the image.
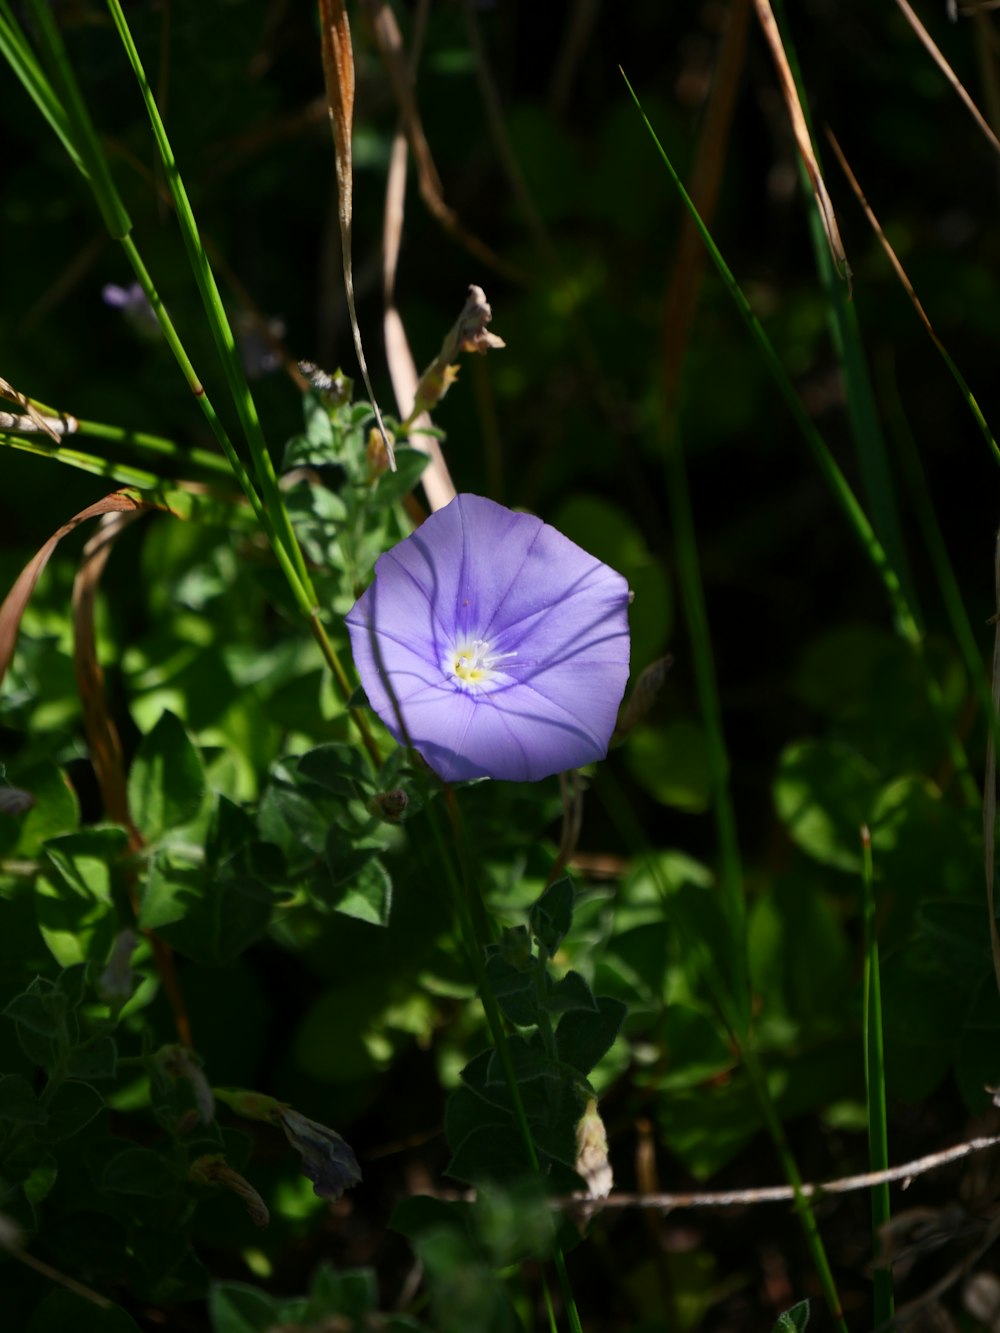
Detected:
[623,71,979,802]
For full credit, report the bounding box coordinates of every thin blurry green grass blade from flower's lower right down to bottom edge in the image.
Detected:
[595,765,848,1333]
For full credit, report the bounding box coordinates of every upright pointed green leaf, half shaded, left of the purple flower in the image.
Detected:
[128,713,205,842]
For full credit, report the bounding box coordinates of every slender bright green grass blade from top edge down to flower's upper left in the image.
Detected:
[108,0,316,597]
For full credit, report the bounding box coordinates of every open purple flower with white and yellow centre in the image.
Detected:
[347,495,629,781]
